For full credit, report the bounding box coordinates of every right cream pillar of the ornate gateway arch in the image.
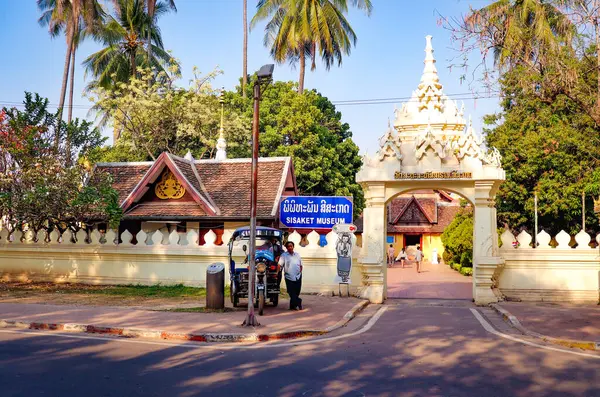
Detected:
[473,181,504,305]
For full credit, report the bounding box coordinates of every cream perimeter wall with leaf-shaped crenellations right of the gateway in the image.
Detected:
[498,227,600,302]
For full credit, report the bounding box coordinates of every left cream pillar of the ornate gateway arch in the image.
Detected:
[359,183,387,303]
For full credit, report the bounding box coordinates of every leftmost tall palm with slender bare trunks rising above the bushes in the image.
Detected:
[37,0,105,150]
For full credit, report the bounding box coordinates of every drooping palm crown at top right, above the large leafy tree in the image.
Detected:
[464,0,575,70]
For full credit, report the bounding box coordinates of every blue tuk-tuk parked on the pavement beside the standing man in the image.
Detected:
[228,226,283,315]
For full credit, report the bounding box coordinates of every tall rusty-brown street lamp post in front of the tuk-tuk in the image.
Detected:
[243,64,274,327]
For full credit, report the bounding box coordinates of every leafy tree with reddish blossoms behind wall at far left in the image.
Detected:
[0,93,121,232]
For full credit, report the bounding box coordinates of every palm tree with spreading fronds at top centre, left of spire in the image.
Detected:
[251,0,373,93]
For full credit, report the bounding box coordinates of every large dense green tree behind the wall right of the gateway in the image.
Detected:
[485,63,600,234]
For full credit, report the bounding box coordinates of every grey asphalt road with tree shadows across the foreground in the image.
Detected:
[0,300,600,397]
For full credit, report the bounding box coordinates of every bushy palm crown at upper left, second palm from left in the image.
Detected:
[83,0,171,88]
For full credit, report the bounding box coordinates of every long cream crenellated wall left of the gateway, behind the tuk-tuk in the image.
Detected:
[0,226,360,294]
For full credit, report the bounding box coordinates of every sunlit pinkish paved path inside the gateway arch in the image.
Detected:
[387,261,473,300]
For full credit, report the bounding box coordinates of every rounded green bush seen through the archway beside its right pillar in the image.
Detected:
[442,207,473,267]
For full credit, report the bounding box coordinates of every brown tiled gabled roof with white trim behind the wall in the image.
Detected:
[97,152,298,220]
